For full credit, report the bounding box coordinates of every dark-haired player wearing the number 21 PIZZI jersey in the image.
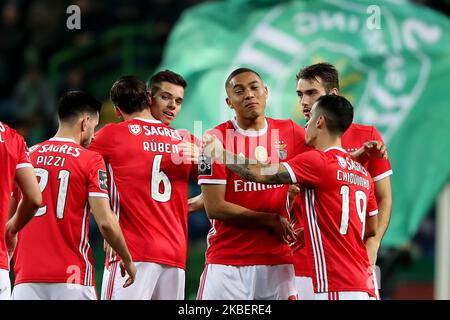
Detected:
[12,91,136,300]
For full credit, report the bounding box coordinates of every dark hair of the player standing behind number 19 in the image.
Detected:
[297,62,339,92]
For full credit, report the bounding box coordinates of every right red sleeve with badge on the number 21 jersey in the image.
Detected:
[89,153,109,198]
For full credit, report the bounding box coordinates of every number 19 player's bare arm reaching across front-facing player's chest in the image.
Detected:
[203,135,293,184]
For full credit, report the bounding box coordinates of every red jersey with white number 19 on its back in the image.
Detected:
[283,148,378,295]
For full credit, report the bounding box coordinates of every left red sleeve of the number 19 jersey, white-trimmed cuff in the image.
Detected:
[282,150,326,186]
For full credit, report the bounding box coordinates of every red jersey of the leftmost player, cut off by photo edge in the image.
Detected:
[0,122,32,270]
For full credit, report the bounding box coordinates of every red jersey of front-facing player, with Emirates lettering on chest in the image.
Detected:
[199,118,306,265]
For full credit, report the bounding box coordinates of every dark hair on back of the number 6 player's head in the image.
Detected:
[109,76,149,114]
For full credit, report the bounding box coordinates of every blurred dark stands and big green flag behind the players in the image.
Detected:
[0,0,450,299]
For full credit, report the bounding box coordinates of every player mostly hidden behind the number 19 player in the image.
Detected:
[294,63,392,298]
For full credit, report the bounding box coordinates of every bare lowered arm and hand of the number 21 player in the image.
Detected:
[89,197,137,288]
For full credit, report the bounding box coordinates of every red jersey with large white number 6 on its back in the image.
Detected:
[89,118,194,269]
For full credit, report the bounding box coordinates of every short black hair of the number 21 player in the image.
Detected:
[58,91,102,122]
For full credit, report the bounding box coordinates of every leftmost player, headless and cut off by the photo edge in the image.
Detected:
[0,122,42,300]
